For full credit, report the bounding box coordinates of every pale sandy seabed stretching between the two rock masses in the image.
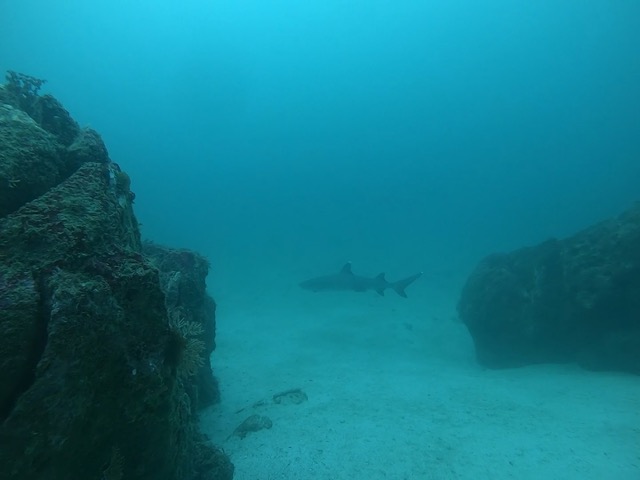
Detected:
[201,278,640,480]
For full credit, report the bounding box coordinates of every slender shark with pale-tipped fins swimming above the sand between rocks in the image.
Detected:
[299,262,422,298]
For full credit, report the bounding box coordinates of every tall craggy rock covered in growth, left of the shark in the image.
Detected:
[0,73,233,480]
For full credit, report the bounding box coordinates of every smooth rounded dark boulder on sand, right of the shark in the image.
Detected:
[458,204,640,374]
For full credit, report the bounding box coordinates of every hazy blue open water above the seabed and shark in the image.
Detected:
[0,0,640,284]
